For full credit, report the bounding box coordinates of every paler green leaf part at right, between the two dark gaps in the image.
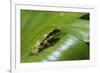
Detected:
[63,19,89,42]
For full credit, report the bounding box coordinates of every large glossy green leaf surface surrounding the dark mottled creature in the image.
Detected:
[21,10,89,63]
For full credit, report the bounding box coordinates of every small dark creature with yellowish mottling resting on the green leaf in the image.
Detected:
[31,29,61,54]
